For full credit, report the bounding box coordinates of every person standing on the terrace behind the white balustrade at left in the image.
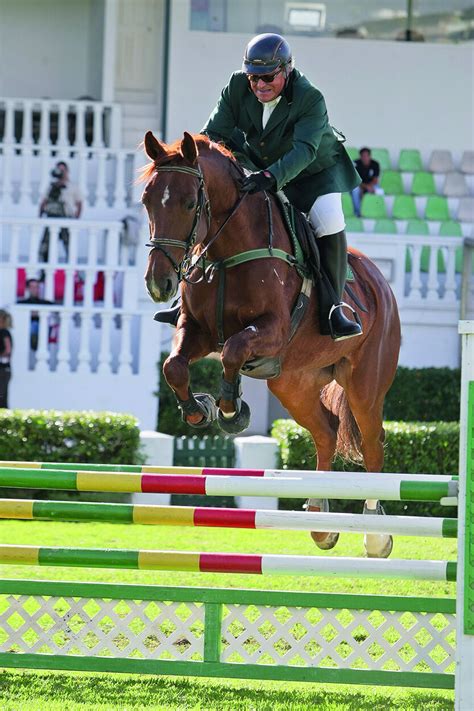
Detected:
[39,161,83,262]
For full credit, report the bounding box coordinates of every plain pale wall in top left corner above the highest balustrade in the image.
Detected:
[0,0,103,100]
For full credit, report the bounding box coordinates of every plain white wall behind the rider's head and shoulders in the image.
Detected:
[166,0,474,162]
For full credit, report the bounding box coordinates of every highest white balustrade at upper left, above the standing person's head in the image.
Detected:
[0,97,122,149]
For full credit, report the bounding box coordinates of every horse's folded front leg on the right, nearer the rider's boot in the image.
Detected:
[218,316,287,434]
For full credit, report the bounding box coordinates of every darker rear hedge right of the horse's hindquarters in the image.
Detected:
[384,367,461,422]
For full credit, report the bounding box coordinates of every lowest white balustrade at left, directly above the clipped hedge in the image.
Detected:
[9,304,160,429]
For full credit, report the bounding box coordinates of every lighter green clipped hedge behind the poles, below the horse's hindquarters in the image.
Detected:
[272,420,459,516]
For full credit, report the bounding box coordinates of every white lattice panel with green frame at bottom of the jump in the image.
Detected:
[0,581,455,688]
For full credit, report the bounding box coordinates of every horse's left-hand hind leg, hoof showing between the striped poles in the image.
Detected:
[268,372,339,550]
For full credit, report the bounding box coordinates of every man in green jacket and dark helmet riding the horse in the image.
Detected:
[155,33,362,340]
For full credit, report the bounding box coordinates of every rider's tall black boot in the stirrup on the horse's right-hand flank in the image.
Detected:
[317,230,362,341]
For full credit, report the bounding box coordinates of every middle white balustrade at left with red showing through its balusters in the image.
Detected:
[0,218,145,310]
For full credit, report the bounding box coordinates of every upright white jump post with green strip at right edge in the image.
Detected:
[455,321,474,711]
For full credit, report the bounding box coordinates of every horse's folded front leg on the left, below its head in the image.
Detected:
[163,317,217,428]
